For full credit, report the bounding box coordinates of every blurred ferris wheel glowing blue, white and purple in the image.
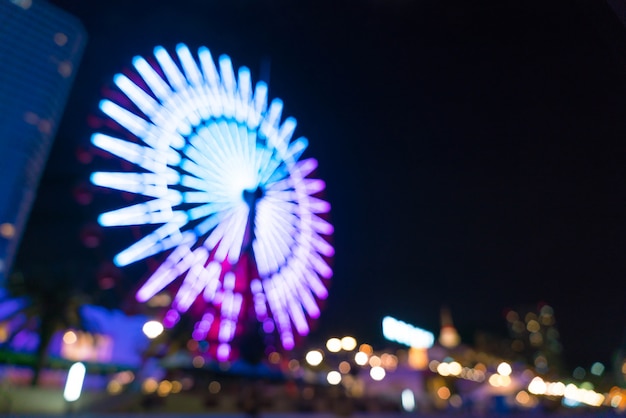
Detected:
[91,44,334,360]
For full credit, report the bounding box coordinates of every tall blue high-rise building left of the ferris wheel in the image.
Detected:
[0,0,86,285]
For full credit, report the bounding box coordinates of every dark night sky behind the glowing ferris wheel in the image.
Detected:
[17,0,626,367]
